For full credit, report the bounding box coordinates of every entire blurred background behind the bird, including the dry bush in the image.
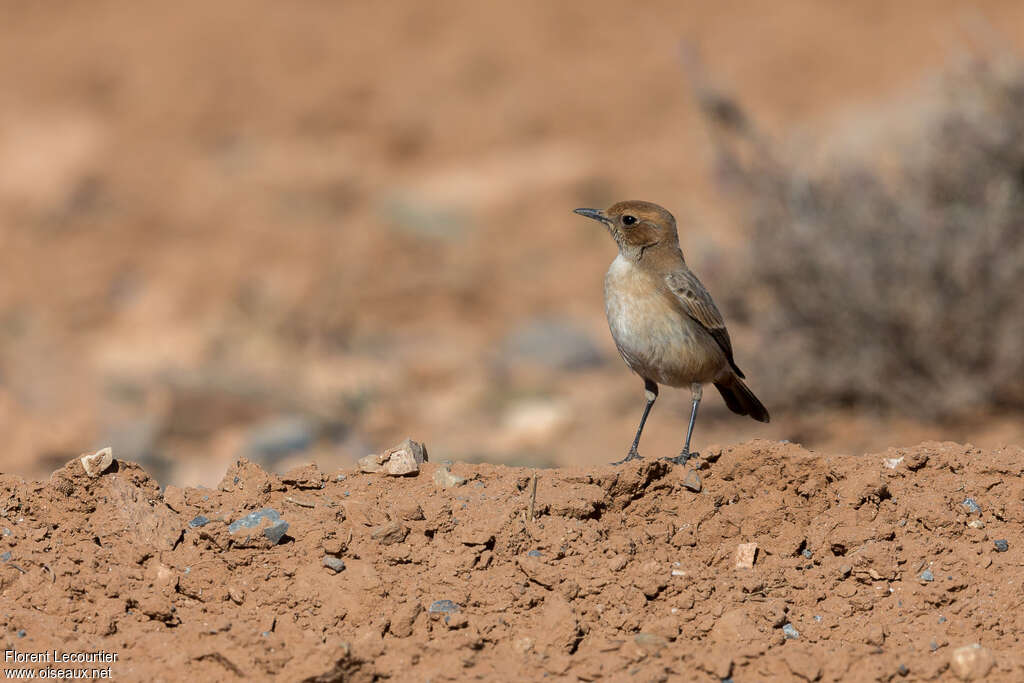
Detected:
[0,0,1024,484]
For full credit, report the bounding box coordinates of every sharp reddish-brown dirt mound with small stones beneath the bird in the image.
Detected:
[0,441,1024,681]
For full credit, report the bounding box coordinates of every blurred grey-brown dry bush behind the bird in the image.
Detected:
[697,60,1024,419]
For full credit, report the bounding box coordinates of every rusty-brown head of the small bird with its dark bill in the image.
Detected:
[574,201,679,261]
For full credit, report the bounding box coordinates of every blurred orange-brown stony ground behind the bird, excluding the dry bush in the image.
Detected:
[6,0,1024,484]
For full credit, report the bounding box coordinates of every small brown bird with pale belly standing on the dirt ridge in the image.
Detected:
[574,201,769,465]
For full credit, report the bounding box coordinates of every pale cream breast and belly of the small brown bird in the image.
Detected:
[604,256,726,386]
